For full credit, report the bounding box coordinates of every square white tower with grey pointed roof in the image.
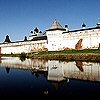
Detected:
[46,20,66,51]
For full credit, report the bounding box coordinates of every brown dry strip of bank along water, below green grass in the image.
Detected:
[32,53,100,62]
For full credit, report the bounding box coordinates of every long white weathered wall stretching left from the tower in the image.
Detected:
[0,40,47,54]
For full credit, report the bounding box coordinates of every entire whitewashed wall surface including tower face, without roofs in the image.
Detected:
[0,29,100,54]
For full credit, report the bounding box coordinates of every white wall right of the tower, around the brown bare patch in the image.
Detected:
[62,29,100,49]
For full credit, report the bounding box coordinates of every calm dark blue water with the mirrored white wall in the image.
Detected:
[0,57,100,100]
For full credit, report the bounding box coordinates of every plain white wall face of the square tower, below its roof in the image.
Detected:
[46,30,63,51]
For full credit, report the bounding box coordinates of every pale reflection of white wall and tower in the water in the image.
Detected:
[0,57,100,82]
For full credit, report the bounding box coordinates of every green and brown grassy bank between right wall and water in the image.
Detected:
[30,50,100,62]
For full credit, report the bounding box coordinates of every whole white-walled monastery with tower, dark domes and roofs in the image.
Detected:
[0,19,100,54]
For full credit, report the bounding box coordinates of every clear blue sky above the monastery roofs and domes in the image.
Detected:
[0,0,100,42]
